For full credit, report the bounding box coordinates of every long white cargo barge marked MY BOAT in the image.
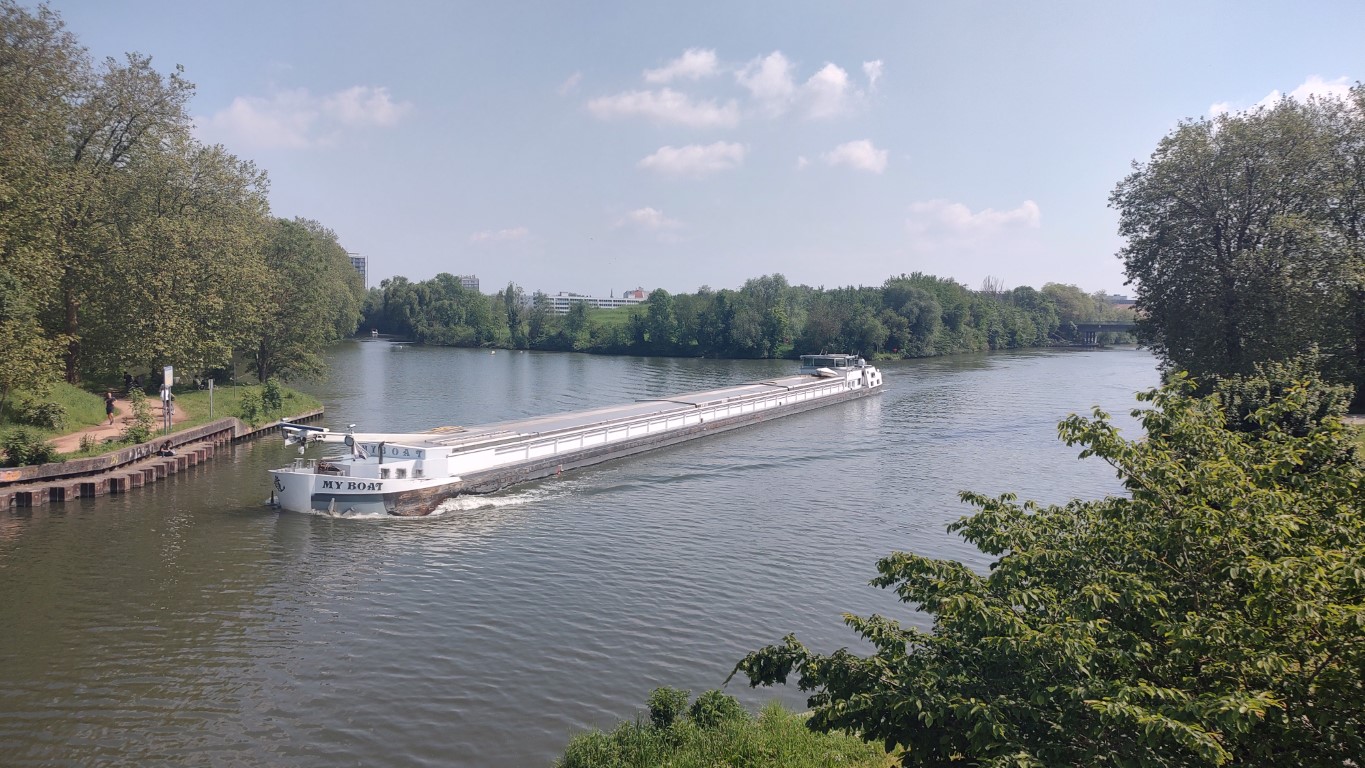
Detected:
[270,355,883,516]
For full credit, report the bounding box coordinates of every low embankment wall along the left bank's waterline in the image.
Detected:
[0,408,322,509]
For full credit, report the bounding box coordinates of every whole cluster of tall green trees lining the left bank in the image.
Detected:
[0,0,364,408]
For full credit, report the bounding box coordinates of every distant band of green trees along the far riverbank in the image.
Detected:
[363,273,1132,357]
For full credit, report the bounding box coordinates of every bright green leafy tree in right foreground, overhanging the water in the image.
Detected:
[736,370,1365,768]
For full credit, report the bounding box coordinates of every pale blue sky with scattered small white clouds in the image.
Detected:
[42,0,1365,296]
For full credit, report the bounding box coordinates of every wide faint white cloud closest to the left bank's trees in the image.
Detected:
[195,86,412,151]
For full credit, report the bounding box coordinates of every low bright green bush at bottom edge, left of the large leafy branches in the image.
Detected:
[556,688,889,768]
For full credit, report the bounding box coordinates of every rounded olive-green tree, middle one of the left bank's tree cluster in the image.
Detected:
[81,135,271,372]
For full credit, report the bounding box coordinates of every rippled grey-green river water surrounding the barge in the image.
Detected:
[0,341,1158,768]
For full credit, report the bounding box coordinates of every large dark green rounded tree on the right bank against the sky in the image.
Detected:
[1110,85,1365,405]
